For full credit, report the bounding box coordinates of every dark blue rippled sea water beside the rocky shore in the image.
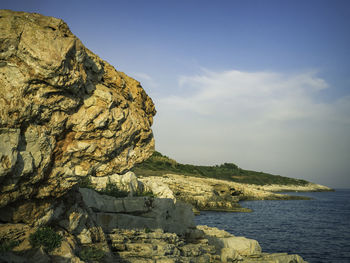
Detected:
[196,189,350,262]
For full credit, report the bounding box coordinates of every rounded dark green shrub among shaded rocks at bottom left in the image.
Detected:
[29,227,62,252]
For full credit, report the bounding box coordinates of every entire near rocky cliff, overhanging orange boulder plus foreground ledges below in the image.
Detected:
[0,10,304,263]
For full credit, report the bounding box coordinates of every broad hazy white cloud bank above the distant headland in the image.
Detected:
[154,70,350,188]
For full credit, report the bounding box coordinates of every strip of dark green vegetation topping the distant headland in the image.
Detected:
[132,151,309,185]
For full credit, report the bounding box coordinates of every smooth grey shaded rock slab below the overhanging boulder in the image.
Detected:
[80,189,195,234]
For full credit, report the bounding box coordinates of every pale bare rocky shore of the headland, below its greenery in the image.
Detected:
[138,174,333,214]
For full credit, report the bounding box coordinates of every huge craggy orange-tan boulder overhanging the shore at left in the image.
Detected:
[0,10,156,222]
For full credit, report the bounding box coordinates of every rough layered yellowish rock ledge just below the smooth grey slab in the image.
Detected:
[108,229,220,263]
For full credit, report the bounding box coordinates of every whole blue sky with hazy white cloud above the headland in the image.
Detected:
[0,0,350,188]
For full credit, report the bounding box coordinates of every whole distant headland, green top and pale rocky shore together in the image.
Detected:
[133,152,333,212]
